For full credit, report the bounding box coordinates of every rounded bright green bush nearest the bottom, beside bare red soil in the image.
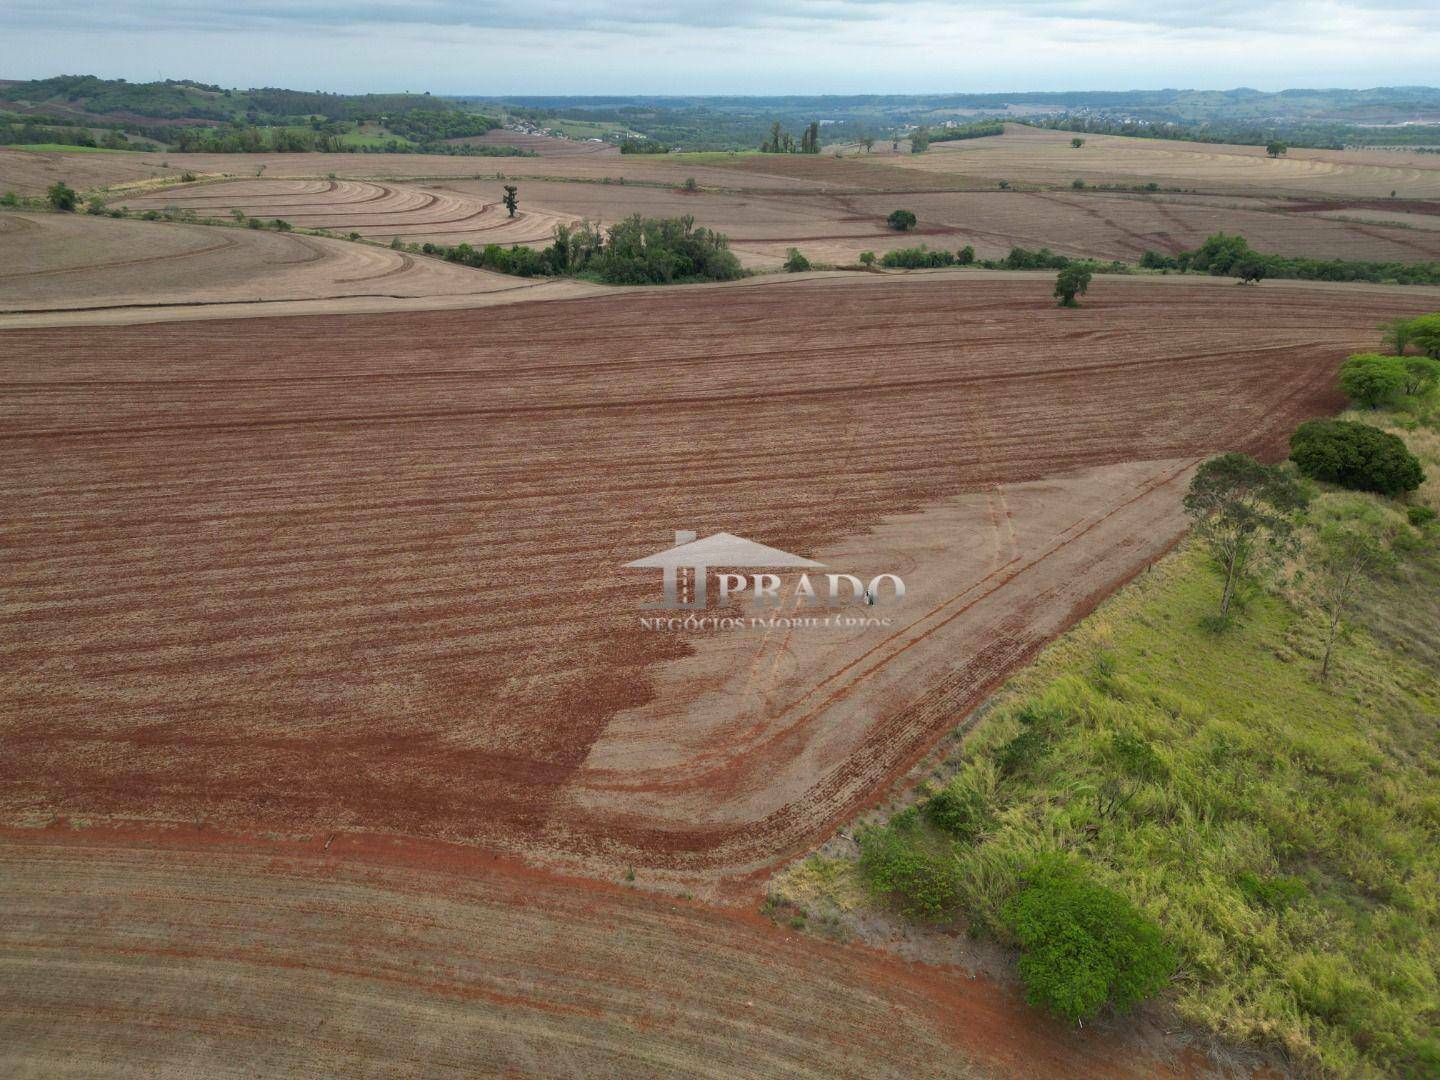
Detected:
[1002,857,1176,1020]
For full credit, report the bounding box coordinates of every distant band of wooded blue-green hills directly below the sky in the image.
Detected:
[0,75,1440,156]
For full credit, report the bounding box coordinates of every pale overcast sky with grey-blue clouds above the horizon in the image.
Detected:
[0,0,1440,95]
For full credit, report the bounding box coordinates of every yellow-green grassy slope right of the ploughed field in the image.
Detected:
[778,415,1440,1074]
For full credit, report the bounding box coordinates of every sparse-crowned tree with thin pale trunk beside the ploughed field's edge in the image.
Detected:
[1185,454,1305,625]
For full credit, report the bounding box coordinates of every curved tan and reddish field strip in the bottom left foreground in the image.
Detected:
[0,834,1179,1080]
